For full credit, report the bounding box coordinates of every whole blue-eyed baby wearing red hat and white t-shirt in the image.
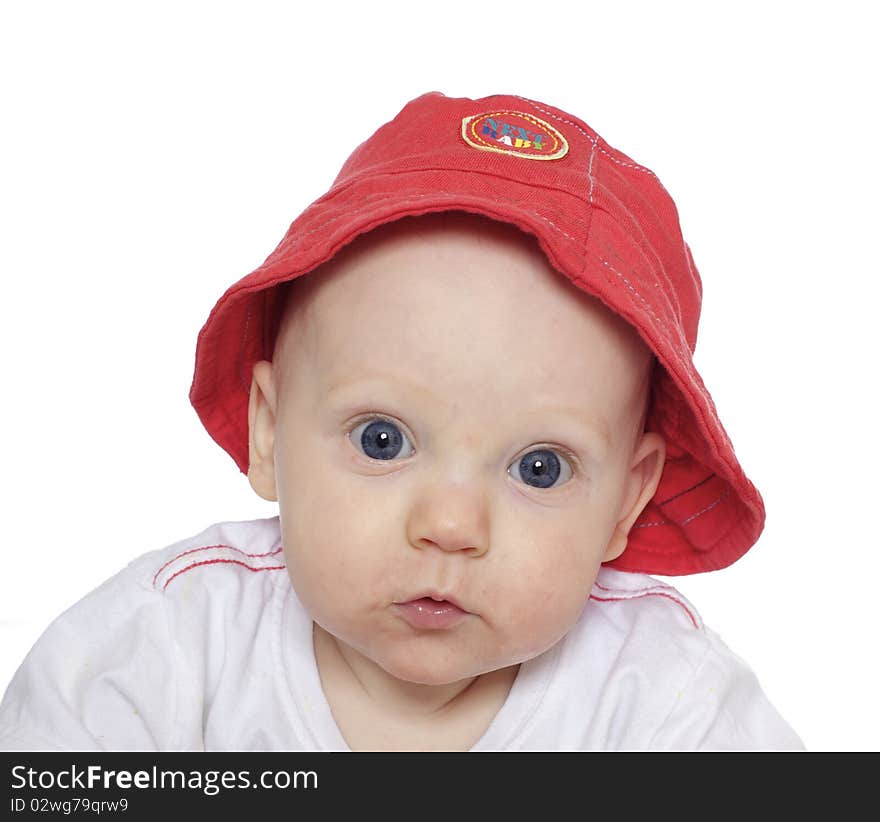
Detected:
[0,93,802,751]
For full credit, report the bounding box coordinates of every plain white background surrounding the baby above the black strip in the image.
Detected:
[0,0,880,750]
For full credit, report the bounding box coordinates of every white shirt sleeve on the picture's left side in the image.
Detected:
[0,555,176,751]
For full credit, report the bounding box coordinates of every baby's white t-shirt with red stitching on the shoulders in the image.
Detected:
[0,517,803,751]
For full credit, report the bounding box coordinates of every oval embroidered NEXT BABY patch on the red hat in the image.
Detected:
[461,111,568,160]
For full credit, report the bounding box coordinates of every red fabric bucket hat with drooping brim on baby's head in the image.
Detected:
[190,92,765,575]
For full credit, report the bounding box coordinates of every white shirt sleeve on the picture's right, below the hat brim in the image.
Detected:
[651,629,804,751]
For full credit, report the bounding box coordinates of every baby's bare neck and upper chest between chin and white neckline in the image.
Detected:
[314,624,519,751]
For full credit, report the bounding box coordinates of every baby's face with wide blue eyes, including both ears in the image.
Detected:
[249,213,665,684]
